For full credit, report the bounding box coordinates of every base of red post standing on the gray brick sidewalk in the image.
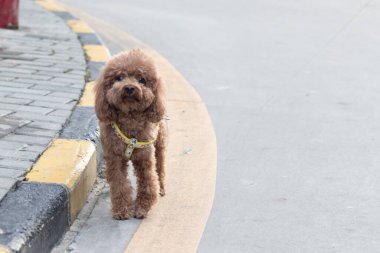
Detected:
[0,0,19,29]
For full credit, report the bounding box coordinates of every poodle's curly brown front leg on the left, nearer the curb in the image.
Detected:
[106,157,134,220]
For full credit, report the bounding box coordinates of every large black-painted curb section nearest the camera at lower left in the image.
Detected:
[0,182,69,253]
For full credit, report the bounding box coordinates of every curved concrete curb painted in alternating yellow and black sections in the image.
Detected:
[0,0,110,253]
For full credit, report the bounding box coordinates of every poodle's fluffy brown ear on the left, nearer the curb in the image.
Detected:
[95,69,116,122]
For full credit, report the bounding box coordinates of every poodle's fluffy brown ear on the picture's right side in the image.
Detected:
[144,78,166,123]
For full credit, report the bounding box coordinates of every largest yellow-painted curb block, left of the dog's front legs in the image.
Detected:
[26,139,96,220]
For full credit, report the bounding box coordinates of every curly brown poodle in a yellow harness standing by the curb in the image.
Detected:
[95,50,166,220]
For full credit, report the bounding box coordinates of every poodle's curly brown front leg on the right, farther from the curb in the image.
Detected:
[133,147,159,219]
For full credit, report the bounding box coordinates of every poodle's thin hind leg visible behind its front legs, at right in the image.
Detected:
[155,122,167,196]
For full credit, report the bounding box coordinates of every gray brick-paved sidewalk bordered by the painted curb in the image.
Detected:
[0,0,86,200]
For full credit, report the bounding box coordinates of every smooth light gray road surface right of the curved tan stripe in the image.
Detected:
[58,0,380,253]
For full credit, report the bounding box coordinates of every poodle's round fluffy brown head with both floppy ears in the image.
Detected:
[95,50,165,122]
